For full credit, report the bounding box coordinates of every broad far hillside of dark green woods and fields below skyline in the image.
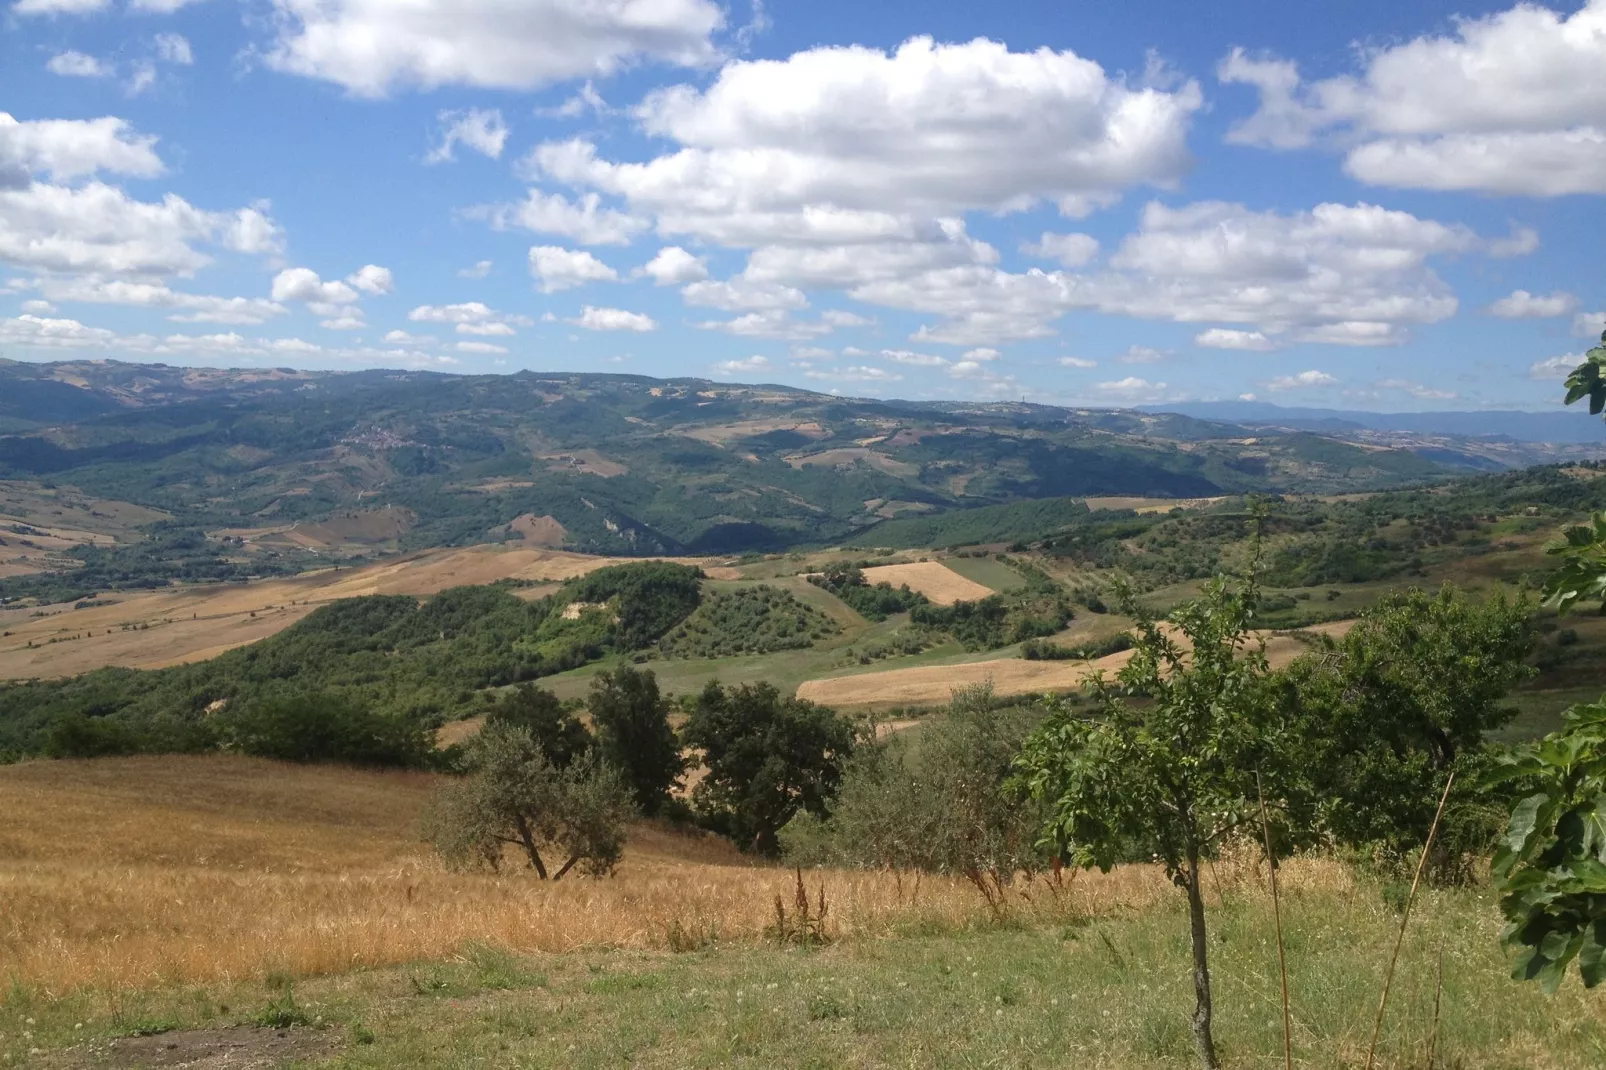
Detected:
[0,361,1528,601]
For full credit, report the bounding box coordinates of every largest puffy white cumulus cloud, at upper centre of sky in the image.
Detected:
[528,37,1201,244]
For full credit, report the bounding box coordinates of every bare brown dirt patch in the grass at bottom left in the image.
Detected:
[55,1025,336,1070]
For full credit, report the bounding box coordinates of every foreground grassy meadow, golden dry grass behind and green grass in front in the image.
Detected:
[0,757,1606,1070]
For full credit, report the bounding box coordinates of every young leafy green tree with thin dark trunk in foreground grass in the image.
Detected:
[1017,572,1294,1070]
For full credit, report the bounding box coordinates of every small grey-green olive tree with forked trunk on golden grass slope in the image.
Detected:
[422,721,636,880]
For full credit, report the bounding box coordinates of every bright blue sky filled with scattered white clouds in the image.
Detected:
[0,0,1606,410]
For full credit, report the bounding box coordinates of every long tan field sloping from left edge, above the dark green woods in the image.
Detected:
[0,546,716,680]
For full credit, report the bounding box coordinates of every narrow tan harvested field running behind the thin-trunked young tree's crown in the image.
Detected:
[798,620,1354,707]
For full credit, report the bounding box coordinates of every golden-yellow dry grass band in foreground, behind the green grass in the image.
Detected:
[0,755,1349,994]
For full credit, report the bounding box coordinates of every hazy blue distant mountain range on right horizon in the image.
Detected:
[1143,402,1606,447]
